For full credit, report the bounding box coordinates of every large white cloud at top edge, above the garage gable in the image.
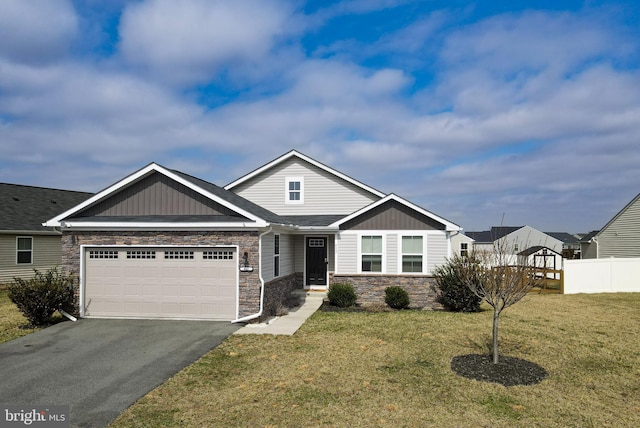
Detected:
[119,0,292,84]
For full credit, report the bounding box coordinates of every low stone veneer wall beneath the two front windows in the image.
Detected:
[330,274,442,309]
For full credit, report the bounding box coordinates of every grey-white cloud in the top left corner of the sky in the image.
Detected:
[0,0,78,64]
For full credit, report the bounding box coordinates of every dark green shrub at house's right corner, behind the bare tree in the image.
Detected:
[434,255,482,312]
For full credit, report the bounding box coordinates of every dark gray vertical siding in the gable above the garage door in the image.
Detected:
[81,173,237,216]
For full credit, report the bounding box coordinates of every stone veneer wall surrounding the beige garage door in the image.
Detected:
[62,231,260,317]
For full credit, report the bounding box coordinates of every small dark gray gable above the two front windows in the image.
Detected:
[340,200,446,230]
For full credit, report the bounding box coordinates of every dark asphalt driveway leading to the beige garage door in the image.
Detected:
[0,319,239,427]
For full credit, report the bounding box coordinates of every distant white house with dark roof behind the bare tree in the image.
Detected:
[466,226,562,260]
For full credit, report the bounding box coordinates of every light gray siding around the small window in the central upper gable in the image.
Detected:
[232,158,380,215]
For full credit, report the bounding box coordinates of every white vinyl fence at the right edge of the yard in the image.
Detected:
[564,258,640,294]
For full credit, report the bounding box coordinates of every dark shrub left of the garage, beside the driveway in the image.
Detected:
[9,268,76,325]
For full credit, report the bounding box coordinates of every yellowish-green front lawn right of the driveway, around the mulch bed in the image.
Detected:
[113,293,640,427]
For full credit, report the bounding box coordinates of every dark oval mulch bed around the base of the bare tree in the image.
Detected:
[451,354,549,386]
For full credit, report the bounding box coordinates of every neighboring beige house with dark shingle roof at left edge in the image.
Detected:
[0,183,91,284]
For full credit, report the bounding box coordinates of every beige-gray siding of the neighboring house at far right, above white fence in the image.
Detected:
[597,195,640,258]
